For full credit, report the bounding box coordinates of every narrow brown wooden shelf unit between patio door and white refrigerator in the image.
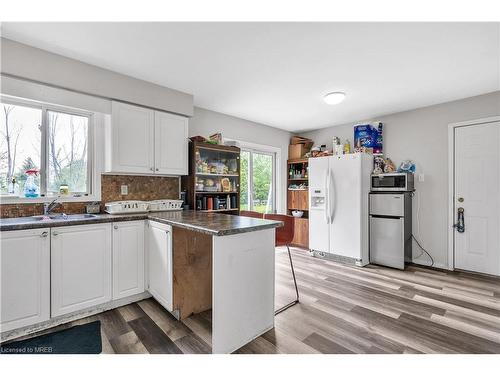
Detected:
[287,158,309,249]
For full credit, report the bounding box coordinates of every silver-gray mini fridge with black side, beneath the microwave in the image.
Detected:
[370,192,412,269]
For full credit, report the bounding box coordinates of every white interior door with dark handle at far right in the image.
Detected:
[454,122,500,275]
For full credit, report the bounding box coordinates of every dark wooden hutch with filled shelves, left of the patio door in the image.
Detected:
[181,141,240,215]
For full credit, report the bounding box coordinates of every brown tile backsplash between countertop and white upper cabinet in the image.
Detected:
[0,175,179,218]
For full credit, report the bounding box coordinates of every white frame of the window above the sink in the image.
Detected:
[0,95,101,204]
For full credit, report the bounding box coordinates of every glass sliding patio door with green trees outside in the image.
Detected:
[240,148,276,213]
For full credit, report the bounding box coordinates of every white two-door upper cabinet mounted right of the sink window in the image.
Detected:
[105,102,188,175]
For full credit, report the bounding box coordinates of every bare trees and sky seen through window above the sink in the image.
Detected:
[0,103,90,197]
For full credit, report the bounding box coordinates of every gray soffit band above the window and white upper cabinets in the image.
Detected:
[0,38,193,116]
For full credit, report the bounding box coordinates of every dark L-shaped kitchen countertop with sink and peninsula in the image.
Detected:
[0,211,283,236]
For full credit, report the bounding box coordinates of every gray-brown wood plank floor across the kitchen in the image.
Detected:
[7,249,500,354]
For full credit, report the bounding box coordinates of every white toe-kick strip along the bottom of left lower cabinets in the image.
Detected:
[0,292,151,342]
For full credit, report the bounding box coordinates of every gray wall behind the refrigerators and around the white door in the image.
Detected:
[301,91,500,268]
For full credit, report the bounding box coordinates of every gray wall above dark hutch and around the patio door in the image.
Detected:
[189,107,290,212]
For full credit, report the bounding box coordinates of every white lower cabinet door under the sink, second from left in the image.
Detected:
[51,224,111,317]
